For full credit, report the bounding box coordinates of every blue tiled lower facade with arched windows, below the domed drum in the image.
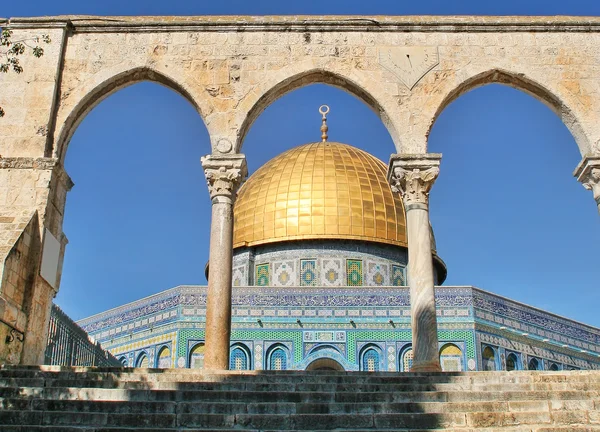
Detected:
[79,286,600,371]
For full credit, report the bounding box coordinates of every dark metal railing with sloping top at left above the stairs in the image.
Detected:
[44,304,123,366]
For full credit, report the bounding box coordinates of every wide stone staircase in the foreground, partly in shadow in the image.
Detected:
[0,366,600,432]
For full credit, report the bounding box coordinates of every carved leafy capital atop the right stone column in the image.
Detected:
[388,153,442,210]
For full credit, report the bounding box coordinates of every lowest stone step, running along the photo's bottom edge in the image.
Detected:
[0,411,568,430]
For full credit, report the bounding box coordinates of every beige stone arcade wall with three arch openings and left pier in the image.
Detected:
[0,16,600,362]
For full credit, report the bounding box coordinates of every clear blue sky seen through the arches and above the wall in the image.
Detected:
[0,0,600,326]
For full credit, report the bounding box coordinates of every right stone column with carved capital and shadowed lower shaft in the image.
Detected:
[388,153,442,372]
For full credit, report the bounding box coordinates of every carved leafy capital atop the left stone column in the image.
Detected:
[200,154,248,204]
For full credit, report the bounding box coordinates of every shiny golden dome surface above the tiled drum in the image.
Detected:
[233,142,407,248]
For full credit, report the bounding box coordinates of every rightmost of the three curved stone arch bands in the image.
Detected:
[426,68,591,155]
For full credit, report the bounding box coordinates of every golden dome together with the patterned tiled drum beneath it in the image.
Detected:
[233,141,446,287]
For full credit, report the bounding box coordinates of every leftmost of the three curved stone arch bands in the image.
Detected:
[52,66,210,163]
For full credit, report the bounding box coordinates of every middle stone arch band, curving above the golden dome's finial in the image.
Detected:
[234,66,400,152]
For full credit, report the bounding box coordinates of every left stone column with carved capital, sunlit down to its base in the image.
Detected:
[202,154,247,370]
